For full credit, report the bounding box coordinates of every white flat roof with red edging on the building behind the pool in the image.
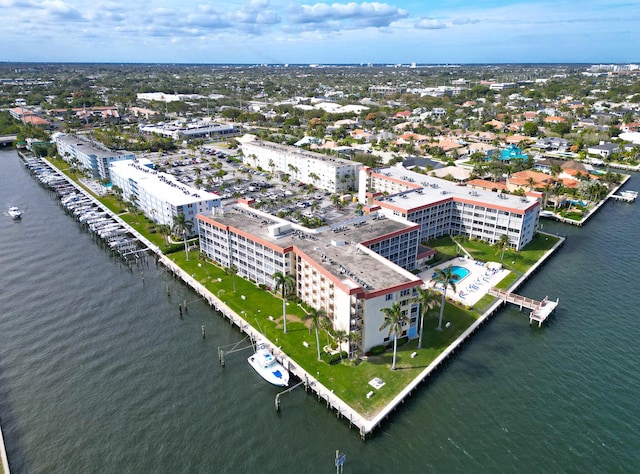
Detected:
[372,166,538,213]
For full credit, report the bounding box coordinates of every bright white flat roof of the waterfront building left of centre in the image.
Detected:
[111,160,220,206]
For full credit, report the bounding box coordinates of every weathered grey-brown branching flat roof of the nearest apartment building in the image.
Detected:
[202,206,419,292]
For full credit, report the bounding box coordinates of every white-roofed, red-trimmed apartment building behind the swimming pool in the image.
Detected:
[358,167,540,250]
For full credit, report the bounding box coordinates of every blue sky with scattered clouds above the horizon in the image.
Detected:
[0,0,640,64]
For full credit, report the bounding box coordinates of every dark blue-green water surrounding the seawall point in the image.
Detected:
[0,150,640,474]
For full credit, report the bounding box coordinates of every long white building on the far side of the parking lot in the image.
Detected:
[242,139,360,193]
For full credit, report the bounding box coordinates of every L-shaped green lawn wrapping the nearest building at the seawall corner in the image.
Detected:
[170,252,479,417]
